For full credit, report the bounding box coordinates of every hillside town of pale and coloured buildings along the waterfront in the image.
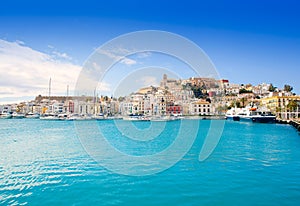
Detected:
[0,74,300,120]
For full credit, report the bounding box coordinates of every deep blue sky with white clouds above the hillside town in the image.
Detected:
[0,0,300,103]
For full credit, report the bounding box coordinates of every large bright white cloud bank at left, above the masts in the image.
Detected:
[0,40,81,102]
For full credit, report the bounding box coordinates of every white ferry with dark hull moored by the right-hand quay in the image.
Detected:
[225,107,276,123]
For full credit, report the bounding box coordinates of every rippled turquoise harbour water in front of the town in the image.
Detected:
[0,119,300,205]
